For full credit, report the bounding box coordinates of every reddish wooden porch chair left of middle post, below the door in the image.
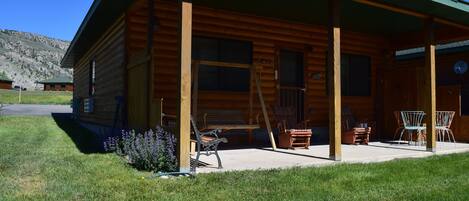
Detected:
[274,107,312,149]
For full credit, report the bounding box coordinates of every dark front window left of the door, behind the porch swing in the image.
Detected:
[192,37,252,91]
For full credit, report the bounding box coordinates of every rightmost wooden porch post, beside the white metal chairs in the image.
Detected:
[423,18,436,152]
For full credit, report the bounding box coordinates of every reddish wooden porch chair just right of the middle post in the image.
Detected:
[342,108,374,145]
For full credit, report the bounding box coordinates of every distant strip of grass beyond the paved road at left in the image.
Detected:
[0,89,72,105]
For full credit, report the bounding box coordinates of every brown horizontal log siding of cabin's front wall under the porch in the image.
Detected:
[129,1,388,126]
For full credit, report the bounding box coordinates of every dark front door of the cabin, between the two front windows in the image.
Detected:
[277,49,305,122]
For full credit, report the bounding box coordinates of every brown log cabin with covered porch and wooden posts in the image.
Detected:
[62,0,469,171]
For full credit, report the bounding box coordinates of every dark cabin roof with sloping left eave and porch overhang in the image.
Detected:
[62,0,469,68]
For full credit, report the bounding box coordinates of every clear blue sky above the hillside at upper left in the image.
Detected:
[0,0,93,40]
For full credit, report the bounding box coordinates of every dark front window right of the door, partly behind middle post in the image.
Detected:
[326,54,371,96]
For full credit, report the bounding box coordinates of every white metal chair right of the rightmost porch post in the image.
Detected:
[436,111,456,143]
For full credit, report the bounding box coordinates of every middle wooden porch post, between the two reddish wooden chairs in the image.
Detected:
[327,0,342,161]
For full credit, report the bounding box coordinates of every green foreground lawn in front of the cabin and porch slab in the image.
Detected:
[0,117,469,201]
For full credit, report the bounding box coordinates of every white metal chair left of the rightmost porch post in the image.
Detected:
[398,111,426,144]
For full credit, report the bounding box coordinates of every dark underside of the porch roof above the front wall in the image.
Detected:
[193,0,423,36]
